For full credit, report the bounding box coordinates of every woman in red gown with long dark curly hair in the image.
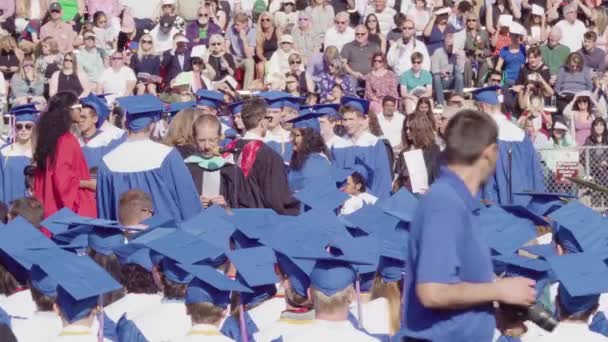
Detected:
[33,92,97,218]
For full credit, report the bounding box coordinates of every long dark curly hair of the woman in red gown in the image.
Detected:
[34,92,78,171]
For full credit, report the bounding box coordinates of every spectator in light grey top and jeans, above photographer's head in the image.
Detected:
[431,32,464,106]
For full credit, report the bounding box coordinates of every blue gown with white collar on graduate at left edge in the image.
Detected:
[0,144,32,204]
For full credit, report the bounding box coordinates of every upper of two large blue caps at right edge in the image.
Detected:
[549,201,608,253]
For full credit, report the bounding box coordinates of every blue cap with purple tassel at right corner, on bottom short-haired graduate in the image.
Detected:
[179,264,252,309]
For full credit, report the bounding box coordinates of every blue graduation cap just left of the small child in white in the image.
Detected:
[294,180,349,210]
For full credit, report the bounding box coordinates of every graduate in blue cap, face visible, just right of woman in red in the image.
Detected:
[78,94,127,169]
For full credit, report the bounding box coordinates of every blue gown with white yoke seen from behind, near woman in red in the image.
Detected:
[97,139,202,222]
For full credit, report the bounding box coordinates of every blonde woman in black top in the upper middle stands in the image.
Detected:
[255,12,283,83]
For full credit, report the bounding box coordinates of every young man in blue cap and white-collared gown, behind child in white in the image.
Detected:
[334,96,392,199]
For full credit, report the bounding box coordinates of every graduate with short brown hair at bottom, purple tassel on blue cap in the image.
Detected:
[175,265,251,342]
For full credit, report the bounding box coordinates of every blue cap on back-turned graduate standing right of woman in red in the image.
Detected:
[116,94,164,132]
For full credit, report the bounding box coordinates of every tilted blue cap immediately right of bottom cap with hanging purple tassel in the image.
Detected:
[226,246,278,306]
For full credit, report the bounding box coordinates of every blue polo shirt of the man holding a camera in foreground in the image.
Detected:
[402,167,495,342]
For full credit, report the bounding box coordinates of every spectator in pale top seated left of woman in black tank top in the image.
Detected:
[11,56,46,105]
